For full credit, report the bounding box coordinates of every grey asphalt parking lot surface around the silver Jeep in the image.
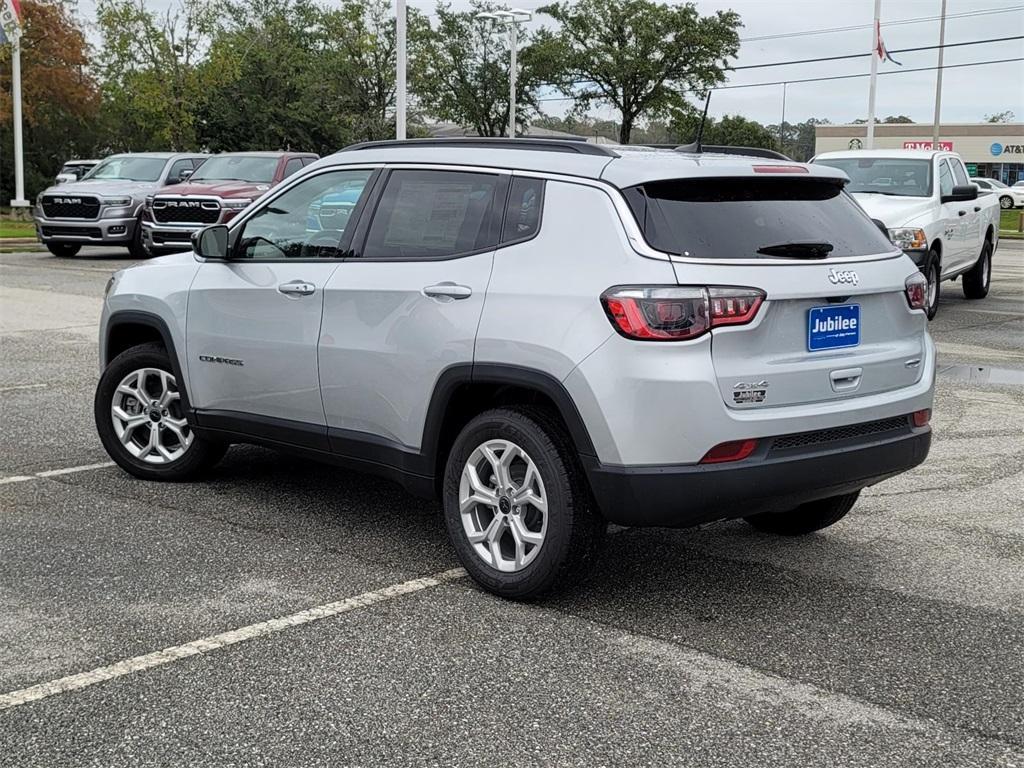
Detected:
[0,242,1024,768]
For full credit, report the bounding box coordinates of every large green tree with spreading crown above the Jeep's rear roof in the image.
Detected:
[532,0,741,143]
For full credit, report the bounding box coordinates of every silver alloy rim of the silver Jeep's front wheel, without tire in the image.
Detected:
[111,368,194,464]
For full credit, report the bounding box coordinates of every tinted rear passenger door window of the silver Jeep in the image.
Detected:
[362,171,499,258]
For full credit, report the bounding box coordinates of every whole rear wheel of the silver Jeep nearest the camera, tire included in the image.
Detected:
[442,407,607,600]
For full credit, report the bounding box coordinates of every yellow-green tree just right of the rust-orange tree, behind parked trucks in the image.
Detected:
[96,0,223,150]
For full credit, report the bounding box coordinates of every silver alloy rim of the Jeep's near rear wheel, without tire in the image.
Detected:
[459,439,548,572]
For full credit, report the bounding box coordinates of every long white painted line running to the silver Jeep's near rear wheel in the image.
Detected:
[0,568,466,711]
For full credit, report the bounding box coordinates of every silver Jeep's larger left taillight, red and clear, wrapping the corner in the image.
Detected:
[601,286,765,341]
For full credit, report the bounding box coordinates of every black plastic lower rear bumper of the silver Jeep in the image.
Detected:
[581,419,932,527]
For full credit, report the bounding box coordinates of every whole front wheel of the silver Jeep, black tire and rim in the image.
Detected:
[93,344,227,480]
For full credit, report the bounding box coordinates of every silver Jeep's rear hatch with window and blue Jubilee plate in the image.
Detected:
[626,174,927,409]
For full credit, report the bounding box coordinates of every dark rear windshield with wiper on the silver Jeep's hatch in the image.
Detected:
[624,177,893,260]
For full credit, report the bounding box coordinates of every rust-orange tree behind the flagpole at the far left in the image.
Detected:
[0,0,99,199]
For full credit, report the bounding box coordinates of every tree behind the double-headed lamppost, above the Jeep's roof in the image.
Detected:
[413,0,541,136]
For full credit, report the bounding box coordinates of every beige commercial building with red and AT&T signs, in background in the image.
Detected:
[814,123,1024,184]
